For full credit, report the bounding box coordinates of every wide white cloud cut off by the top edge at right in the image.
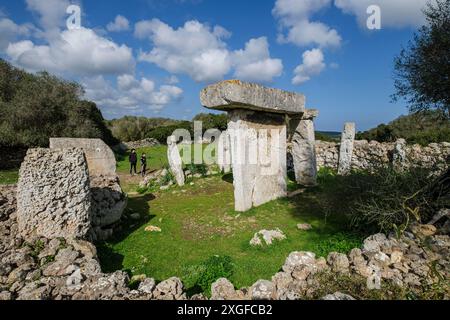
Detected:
[334,0,435,28]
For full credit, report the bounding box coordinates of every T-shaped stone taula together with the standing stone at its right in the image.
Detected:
[200,80,318,211]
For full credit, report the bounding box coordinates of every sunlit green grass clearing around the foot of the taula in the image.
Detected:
[99,161,362,292]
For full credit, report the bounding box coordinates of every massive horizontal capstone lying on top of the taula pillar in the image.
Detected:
[200,80,305,114]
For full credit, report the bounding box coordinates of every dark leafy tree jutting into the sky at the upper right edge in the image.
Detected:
[392,0,450,118]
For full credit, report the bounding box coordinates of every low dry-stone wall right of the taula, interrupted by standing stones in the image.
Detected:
[310,140,450,170]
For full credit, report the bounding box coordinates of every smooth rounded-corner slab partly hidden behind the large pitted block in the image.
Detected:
[50,138,116,176]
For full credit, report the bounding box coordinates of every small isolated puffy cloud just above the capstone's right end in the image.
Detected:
[292,49,326,85]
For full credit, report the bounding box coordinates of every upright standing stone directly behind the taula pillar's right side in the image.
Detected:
[291,110,318,186]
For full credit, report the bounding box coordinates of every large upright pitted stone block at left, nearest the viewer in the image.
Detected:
[17,149,91,238]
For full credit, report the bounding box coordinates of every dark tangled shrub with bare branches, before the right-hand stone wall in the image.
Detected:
[344,167,444,232]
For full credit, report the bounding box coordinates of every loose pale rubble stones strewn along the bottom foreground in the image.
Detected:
[0,186,450,300]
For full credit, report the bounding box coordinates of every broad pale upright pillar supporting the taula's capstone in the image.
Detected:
[228,109,287,211]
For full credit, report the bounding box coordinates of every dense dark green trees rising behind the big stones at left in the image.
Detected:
[0,59,118,148]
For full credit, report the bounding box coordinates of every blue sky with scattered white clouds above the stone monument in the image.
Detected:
[0,0,427,131]
